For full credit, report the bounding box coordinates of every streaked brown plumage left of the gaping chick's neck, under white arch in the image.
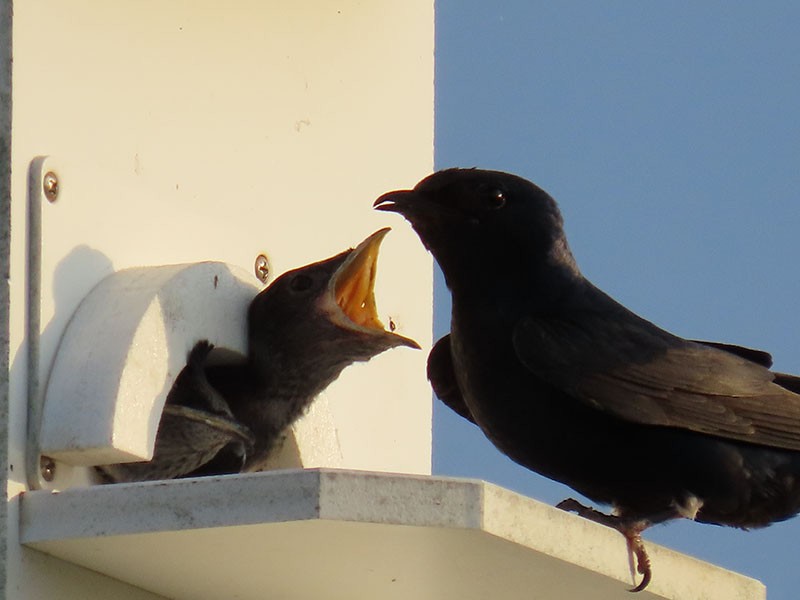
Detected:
[96,340,255,483]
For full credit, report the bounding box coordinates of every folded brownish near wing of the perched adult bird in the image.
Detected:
[513,311,800,450]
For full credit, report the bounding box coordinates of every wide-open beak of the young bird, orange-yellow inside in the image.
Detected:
[329,227,420,349]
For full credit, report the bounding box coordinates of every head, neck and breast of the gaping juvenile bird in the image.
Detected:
[206,228,419,472]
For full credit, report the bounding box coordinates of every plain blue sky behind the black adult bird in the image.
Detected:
[432,0,800,600]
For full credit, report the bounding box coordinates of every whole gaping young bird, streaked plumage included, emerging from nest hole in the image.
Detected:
[98,228,419,481]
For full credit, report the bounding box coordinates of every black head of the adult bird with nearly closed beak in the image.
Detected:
[374,169,577,288]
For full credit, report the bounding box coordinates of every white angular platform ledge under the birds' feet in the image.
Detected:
[20,469,766,600]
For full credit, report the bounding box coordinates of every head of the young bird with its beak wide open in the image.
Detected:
[248,228,419,384]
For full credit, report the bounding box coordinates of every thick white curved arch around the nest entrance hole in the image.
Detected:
[40,262,259,466]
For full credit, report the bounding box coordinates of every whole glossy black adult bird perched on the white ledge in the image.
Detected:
[375,169,800,591]
